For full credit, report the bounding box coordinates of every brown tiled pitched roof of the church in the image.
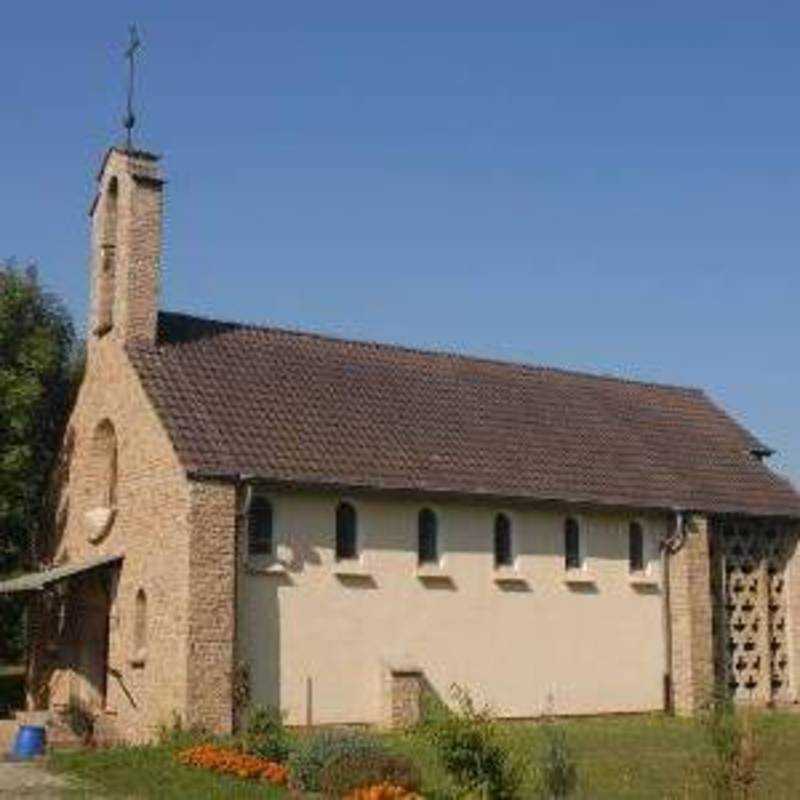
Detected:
[123,313,800,516]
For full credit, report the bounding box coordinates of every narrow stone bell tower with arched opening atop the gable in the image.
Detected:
[89,148,164,343]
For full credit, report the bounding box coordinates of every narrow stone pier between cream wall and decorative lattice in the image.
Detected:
[670,515,714,714]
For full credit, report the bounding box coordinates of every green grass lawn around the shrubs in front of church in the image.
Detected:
[50,713,800,800]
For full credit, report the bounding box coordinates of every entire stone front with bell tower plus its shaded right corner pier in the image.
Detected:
[34,149,242,741]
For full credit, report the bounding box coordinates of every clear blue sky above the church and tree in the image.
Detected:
[0,0,800,488]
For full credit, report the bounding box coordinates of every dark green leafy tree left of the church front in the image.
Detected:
[0,262,77,661]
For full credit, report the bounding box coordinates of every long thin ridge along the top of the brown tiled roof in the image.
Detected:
[158,311,705,396]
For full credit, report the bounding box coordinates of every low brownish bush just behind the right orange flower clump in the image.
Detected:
[319,751,422,800]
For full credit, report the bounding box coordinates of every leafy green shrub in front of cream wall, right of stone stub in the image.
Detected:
[421,686,520,800]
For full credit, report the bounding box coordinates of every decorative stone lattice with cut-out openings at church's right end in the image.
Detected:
[711,521,794,703]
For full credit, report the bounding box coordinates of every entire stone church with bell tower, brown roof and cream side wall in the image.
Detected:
[0,148,800,741]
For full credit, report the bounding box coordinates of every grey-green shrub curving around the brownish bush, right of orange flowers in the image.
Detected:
[289,731,386,792]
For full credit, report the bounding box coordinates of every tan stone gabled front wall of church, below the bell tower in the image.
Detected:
[48,337,195,740]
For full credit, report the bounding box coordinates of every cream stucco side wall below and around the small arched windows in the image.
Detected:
[238,493,666,724]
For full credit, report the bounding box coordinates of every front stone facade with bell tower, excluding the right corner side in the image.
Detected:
[40,149,195,740]
